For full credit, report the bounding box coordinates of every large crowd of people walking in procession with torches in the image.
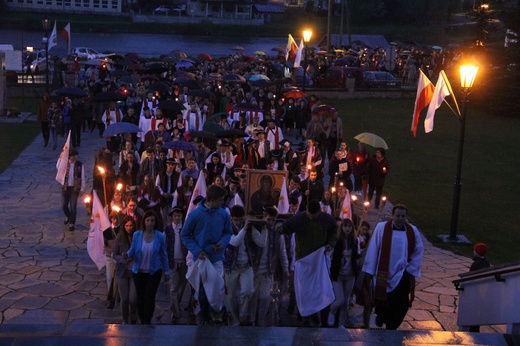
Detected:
[38,49,422,329]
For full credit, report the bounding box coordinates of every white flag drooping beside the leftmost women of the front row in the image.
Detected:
[87,190,110,270]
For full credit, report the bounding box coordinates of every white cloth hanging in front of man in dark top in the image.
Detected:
[294,247,336,317]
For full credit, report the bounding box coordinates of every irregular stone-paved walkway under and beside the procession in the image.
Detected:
[0,117,505,333]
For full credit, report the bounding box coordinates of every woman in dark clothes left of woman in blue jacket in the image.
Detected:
[112,216,137,324]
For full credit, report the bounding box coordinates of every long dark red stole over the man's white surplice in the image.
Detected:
[375,220,415,301]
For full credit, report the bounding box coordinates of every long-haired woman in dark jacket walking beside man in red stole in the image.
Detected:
[327,219,359,327]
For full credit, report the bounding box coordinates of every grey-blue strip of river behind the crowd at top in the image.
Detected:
[0,29,287,57]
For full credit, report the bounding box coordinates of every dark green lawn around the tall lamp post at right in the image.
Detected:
[325,99,520,264]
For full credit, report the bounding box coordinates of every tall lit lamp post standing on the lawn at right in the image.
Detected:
[450,65,478,241]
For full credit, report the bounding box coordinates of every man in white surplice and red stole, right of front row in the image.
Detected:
[363,204,424,330]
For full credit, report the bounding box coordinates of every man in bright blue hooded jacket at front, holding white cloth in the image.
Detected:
[181,185,233,324]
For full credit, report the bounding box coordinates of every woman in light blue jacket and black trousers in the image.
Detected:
[127,210,170,324]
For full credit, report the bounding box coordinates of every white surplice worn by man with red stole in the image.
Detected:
[363,222,424,292]
